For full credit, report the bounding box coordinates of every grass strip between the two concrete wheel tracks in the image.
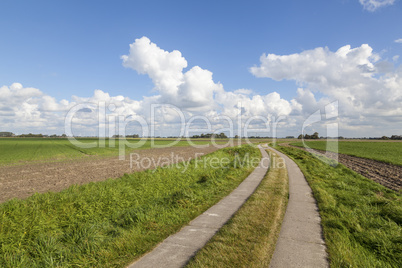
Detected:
[187,150,289,267]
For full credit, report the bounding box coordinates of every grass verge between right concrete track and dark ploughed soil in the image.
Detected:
[277,146,402,267]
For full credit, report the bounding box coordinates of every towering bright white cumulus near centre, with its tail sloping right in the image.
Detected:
[121,37,292,130]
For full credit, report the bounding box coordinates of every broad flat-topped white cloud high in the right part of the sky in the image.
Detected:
[250,44,379,84]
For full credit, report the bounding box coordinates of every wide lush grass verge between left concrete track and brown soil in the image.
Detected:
[0,146,260,267]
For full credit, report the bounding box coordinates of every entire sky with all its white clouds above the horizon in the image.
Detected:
[0,0,402,137]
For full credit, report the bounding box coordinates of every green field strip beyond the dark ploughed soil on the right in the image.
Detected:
[291,141,402,166]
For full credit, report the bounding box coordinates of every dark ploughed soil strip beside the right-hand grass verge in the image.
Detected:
[280,143,402,191]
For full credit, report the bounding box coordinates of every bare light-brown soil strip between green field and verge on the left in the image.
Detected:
[0,146,219,203]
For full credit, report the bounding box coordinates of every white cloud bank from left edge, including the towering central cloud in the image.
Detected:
[0,37,299,136]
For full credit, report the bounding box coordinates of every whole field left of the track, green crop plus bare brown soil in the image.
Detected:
[0,138,254,203]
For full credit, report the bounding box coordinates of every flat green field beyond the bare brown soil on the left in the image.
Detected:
[0,138,227,165]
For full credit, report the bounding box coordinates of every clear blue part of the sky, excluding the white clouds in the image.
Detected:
[0,0,402,136]
